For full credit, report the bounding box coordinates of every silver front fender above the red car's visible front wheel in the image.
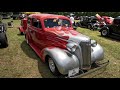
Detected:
[44,48,79,75]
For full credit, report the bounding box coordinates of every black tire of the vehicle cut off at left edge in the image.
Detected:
[0,33,8,48]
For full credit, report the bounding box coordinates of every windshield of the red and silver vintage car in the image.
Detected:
[44,18,71,28]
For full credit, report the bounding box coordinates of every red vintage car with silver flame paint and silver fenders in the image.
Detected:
[25,14,108,78]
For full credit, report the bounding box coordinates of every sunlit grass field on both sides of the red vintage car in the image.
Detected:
[0,20,120,78]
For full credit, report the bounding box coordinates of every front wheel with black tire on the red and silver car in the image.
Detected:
[48,57,60,76]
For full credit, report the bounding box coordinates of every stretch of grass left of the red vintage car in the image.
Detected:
[0,20,54,78]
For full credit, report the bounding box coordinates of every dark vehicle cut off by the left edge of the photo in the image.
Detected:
[0,21,8,48]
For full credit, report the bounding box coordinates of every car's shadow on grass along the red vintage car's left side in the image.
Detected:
[21,41,55,78]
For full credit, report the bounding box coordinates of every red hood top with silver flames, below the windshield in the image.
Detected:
[48,28,90,43]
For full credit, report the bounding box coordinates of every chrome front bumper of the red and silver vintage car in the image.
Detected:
[65,60,109,78]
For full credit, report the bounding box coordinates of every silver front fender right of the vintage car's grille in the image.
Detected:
[91,44,104,62]
